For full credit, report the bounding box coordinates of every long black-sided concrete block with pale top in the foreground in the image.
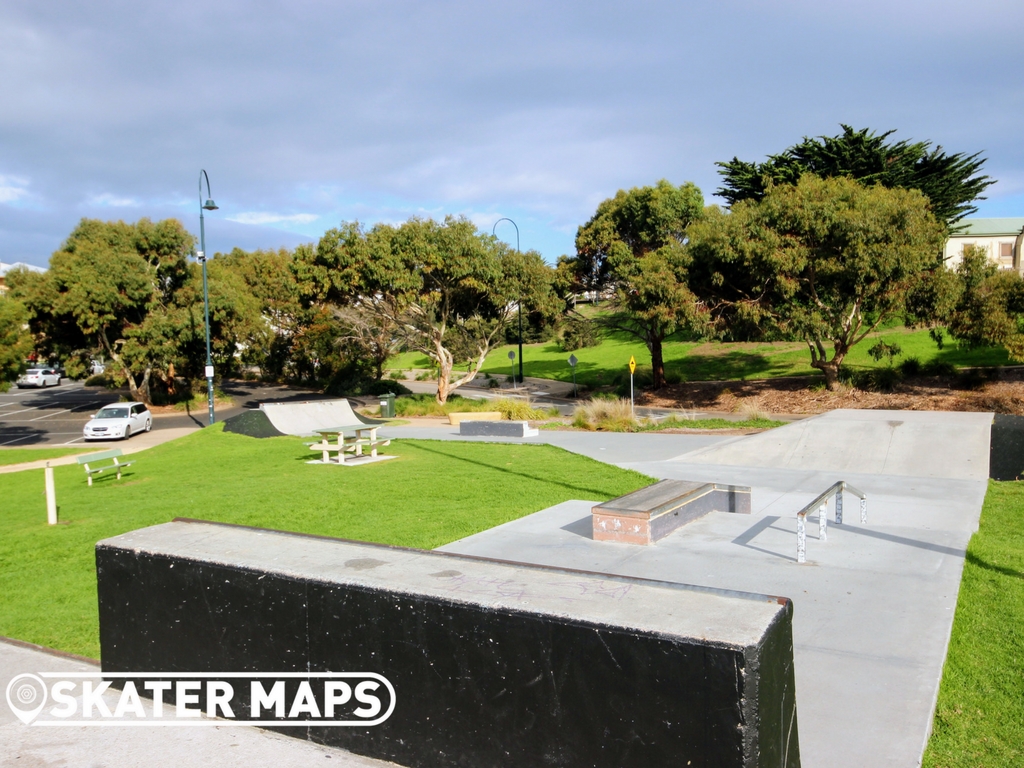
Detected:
[96,520,800,768]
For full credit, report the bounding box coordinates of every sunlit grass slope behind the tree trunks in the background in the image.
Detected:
[389,327,1010,388]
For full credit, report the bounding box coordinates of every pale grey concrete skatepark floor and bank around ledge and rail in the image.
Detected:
[2,412,991,766]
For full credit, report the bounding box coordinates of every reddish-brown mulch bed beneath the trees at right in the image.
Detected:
[638,369,1024,416]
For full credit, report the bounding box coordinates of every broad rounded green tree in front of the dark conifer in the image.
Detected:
[688,174,944,389]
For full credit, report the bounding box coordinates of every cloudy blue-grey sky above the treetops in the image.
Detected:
[0,0,1024,266]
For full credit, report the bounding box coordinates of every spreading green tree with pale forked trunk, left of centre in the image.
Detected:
[295,216,551,402]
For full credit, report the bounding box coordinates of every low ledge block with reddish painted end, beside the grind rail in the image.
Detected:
[592,480,751,544]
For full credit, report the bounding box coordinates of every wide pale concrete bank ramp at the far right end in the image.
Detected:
[676,410,992,480]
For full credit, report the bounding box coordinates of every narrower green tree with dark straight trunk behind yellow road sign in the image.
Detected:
[573,179,703,388]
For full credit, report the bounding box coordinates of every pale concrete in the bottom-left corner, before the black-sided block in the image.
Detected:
[0,641,394,768]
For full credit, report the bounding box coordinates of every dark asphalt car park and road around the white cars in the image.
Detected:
[0,380,335,449]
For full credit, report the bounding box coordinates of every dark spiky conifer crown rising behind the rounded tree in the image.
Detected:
[716,125,994,229]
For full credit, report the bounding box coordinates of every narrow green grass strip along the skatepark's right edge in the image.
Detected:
[924,481,1024,768]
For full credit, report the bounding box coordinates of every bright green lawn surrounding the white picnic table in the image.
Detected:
[0,425,653,657]
